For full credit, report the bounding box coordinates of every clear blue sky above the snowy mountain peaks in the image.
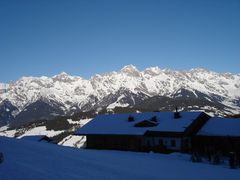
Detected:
[0,0,240,82]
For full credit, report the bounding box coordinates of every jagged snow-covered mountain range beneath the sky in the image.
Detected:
[0,65,240,126]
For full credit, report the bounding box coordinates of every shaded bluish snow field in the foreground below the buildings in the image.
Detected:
[0,137,240,180]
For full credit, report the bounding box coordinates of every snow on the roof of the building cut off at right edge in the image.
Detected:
[197,117,240,136]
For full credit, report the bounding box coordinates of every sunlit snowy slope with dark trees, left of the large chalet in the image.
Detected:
[0,118,91,148]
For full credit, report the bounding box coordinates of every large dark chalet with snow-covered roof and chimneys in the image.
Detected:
[76,112,210,152]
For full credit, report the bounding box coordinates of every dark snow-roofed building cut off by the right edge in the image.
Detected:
[192,117,240,155]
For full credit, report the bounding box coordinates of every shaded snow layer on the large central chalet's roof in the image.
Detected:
[75,112,201,135]
